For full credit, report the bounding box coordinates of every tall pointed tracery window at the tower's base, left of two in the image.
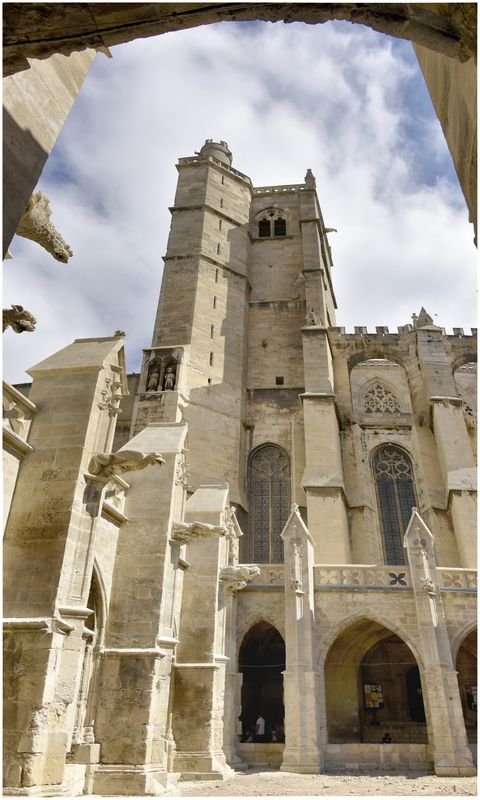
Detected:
[249,444,290,564]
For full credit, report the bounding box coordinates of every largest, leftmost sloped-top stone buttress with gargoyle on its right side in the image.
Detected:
[4,338,126,794]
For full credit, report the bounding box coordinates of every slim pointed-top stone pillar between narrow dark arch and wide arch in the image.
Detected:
[280,505,326,773]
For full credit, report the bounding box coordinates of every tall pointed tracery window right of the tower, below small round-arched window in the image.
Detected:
[373,444,417,564]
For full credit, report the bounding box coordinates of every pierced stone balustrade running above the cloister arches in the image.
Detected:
[240,564,477,593]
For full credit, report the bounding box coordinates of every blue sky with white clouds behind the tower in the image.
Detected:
[3,22,476,383]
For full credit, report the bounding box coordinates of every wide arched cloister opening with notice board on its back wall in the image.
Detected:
[325,619,427,744]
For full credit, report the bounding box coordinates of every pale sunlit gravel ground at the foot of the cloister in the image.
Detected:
[175,768,477,797]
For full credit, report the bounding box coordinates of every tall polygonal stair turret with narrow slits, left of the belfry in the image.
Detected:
[133,140,252,505]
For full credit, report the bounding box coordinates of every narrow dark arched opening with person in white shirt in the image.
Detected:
[238,622,285,742]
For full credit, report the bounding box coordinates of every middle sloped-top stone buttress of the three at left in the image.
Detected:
[93,423,187,796]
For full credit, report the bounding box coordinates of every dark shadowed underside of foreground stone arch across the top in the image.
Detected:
[3,3,476,74]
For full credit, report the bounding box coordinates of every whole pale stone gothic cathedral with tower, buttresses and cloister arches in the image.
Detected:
[3,140,477,796]
